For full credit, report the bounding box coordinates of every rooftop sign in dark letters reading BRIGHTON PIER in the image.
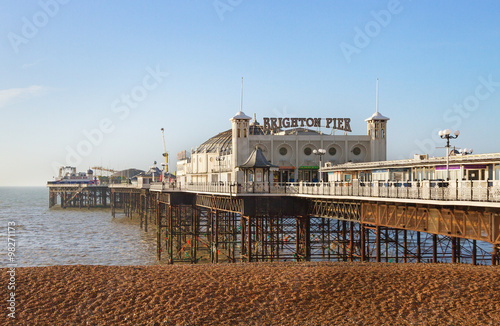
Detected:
[263,118,351,131]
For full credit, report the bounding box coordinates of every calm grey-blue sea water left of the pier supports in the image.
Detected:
[0,187,156,267]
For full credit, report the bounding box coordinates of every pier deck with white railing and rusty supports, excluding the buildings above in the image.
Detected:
[109,181,500,265]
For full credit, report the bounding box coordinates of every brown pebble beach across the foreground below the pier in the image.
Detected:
[0,262,500,325]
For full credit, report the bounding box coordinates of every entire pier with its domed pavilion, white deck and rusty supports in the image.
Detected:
[45,106,500,265]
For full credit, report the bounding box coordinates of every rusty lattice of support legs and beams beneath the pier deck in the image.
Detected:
[102,189,499,264]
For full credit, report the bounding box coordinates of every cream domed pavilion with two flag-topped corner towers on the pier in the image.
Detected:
[177,108,389,183]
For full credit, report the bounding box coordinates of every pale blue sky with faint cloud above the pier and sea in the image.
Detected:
[0,0,500,186]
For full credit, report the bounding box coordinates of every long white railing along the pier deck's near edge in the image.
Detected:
[175,180,500,202]
